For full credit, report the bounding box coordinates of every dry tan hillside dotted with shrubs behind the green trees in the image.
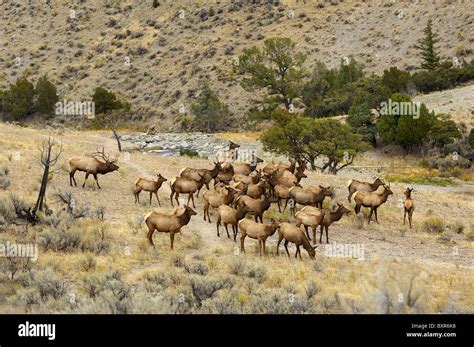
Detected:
[0,0,474,129]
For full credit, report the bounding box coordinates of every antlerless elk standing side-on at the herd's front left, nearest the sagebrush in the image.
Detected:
[145,206,197,249]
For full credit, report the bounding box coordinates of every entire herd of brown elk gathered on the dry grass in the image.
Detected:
[69,142,415,259]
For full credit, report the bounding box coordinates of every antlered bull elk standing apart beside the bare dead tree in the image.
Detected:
[69,148,119,189]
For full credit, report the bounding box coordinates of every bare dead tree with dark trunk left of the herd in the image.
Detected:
[31,136,63,216]
